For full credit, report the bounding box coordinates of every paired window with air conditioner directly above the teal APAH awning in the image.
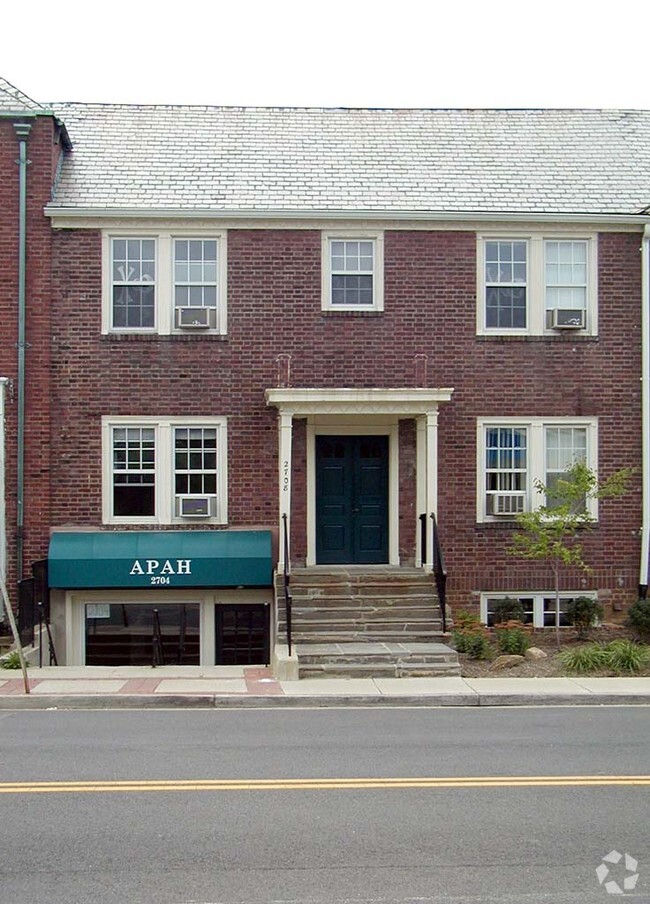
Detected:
[102,417,227,524]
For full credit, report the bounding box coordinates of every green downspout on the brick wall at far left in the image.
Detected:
[14,122,32,581]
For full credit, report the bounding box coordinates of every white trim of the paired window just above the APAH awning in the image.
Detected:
[102,416,228,526]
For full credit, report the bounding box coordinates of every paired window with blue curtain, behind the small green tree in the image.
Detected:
[477,418,598,521]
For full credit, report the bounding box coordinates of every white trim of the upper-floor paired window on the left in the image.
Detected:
[102,227,228,336]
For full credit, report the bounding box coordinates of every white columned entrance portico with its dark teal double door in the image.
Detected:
[265,388,453,570]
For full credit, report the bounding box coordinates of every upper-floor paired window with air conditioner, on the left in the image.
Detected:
[102,232,227,335]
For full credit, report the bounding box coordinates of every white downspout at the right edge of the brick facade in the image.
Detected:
[639,225,650,599]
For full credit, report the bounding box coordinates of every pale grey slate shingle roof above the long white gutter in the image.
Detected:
[52,104,650,215]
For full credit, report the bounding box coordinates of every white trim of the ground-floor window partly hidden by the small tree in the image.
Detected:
[476,417,598,523]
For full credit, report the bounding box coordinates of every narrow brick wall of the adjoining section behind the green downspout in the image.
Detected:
[0,117,59,598]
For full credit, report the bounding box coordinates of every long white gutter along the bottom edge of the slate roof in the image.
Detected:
[43,205,650,226]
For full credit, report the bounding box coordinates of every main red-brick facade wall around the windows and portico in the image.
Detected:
[52,230,641,605]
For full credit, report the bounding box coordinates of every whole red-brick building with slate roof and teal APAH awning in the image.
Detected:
[0,76,650,664]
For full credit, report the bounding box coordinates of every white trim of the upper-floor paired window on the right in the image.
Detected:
[476,229,598,336]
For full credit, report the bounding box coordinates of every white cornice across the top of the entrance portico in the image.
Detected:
[264,388,454,417]
